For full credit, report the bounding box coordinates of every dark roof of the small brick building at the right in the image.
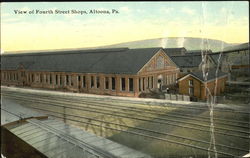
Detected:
[179,69,227,82]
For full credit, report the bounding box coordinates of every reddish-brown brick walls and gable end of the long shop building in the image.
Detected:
[1,51,179,97]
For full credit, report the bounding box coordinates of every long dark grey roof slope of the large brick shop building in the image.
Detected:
[1,47,161,74]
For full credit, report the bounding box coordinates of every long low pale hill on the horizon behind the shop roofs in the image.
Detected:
[5,37,242,54]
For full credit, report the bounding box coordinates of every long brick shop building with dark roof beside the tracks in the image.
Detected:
[1,48,180,97]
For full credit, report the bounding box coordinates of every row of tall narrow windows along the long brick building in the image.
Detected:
[2,72,177,91]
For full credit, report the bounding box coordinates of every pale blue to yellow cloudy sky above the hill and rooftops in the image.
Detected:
[1,1,249,51]
